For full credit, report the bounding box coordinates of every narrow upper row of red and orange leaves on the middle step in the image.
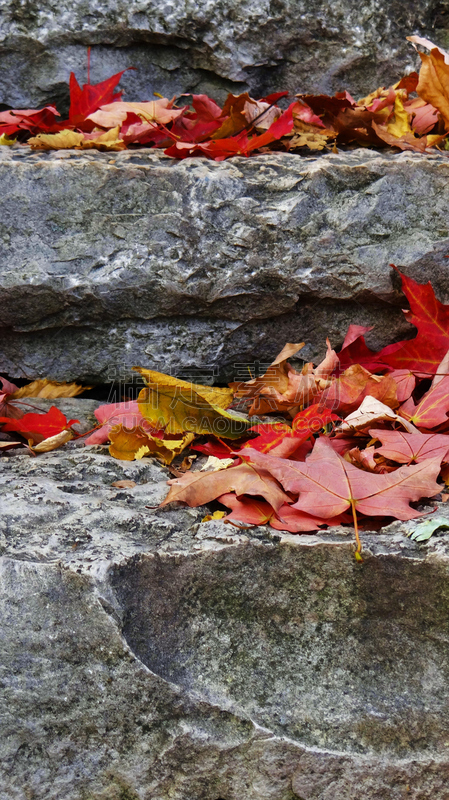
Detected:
[0,36,449,161]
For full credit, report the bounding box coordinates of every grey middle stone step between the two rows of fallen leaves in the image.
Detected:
[0,146,449,382]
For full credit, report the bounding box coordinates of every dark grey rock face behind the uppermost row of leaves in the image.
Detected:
[0,0,449,108]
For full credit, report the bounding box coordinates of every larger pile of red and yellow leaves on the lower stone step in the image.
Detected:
[4,273,449,558]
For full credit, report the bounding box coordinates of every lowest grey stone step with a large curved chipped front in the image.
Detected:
[0,400,449,800]
